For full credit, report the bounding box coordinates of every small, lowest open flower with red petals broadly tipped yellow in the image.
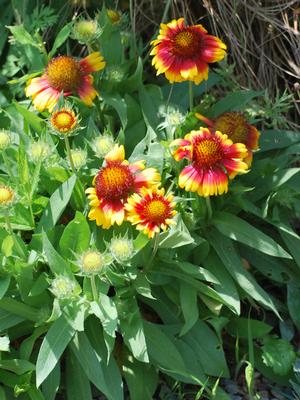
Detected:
[125,187,176,238]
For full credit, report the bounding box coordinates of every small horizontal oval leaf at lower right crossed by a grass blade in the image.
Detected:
[226,317,273,339]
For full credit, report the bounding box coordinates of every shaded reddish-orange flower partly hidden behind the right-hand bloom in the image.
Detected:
[195,111,260,166]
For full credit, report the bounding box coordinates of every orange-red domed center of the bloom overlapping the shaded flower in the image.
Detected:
[193,138,223,167]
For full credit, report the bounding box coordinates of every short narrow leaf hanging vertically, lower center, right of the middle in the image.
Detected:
[180,282,199,336]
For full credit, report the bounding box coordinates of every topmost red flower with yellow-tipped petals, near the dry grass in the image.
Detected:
[150,18,226,85]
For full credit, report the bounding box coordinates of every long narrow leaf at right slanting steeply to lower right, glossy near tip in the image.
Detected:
[206,229,279,316]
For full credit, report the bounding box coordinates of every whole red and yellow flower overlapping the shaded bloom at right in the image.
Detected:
[171,127,248,197]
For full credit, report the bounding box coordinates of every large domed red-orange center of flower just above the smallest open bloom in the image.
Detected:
[96,163,134,200]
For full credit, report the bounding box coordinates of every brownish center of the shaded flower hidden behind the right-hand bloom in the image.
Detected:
[214,112,248,144]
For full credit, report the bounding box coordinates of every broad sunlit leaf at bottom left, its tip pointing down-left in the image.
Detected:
[36,315,75,387]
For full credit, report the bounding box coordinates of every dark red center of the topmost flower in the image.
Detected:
[173,27,202,57]
